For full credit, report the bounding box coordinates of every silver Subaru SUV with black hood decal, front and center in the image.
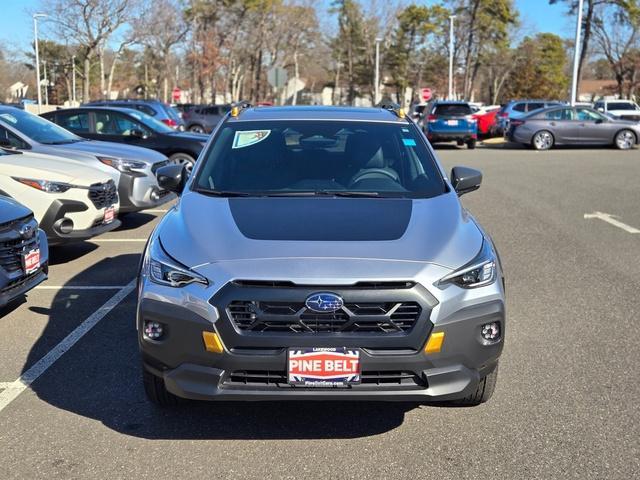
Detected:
[137,104,505,405]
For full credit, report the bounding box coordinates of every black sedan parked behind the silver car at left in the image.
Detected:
[42,107,209,169]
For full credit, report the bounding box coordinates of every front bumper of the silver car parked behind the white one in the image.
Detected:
[118,172,176,213]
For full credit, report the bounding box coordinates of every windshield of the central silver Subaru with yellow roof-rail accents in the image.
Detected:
[195,121,446,198]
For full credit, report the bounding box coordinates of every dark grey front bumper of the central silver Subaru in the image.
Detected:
[137,288,505,402]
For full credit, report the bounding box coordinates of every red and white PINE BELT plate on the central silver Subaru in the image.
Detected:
[287,347,360,387]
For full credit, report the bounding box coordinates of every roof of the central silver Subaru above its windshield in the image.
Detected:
[229,106,408,123]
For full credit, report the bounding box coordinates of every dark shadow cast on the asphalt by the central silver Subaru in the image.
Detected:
[24,255,416,440]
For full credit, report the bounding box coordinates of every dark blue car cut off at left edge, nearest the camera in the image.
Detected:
[0,195,49,315]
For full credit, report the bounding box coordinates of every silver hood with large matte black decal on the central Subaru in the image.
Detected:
[158,192,483,269]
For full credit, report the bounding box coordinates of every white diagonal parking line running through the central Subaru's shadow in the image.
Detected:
[0,279,136,412]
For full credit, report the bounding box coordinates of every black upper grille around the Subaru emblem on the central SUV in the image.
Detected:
[227,300,422,334]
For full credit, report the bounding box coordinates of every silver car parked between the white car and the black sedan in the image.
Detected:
[0,107,175,213]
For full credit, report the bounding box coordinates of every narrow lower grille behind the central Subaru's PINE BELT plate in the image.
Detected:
[224,370,427,388]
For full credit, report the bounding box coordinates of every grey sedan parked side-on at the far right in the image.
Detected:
[507,106,640,150]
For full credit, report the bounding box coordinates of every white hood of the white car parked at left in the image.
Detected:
[0,152,117,187]
